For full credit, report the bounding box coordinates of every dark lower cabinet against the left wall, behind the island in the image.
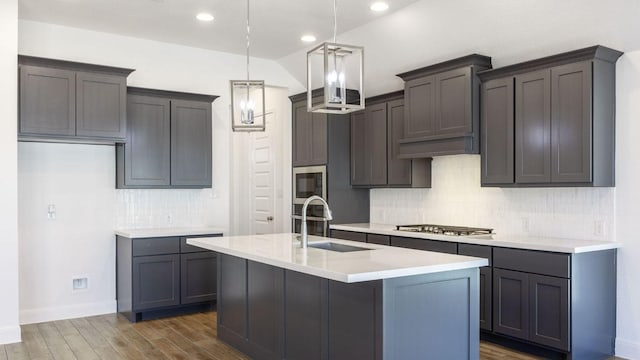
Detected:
[116,234,221,322]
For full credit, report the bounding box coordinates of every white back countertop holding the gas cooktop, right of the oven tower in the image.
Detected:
[330,223,621,254]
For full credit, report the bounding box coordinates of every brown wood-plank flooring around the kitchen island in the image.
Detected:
[0,312,624,360]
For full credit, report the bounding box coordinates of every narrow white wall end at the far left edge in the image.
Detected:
[0,0,20,344]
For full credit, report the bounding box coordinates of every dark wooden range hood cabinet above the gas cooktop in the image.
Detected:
[398,54,491,159]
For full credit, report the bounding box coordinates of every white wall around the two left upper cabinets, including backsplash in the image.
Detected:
[17,21,301,323]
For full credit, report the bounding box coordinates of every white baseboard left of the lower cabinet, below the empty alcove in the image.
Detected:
[20,300,118,325]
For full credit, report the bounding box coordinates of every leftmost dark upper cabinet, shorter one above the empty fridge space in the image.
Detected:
[18,56,133,143]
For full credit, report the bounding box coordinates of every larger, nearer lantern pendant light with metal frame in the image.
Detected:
[307,0,364,114]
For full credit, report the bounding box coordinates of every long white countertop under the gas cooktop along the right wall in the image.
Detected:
[329,223,622,254]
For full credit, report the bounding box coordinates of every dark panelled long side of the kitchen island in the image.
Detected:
[218,254,382,360]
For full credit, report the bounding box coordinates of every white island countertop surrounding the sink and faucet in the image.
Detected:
[187,233,488,283]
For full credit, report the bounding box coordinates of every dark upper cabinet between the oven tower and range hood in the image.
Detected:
[351,91,431,187]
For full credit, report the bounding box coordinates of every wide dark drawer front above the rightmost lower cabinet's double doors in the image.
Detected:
[493,248,571,278]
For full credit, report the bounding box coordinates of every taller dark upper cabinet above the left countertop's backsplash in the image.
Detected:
[116,88,216,188]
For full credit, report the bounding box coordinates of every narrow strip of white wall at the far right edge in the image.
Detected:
[615,51,640,359]
